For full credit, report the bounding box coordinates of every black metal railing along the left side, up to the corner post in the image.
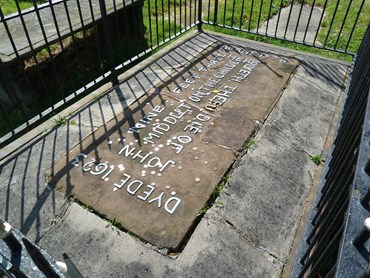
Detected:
[0,0,200,146]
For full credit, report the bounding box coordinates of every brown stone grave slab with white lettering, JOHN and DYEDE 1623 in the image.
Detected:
[50,45,298,250]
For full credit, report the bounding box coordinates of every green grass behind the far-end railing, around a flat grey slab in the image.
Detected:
[203,0,370,61]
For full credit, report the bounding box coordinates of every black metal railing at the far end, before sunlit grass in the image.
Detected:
[203,0,370,55]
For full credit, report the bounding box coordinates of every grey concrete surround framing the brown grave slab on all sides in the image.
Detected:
[0,33,347,277]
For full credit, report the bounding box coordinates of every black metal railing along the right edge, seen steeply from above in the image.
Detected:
[292,22,370,277]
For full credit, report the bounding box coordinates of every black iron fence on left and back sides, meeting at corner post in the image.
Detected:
[0,0,370,146]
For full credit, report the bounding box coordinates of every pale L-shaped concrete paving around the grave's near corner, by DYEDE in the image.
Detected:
[41,203,282,277]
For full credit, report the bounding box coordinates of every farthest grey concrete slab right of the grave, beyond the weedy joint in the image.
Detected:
[268,63,344,155]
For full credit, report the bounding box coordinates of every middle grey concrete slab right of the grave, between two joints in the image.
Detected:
[217,124,315,262]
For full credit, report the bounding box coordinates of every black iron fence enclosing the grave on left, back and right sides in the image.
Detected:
[0,0,370,277]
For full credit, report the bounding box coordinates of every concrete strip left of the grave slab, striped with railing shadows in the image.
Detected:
[0,29,214,248]
